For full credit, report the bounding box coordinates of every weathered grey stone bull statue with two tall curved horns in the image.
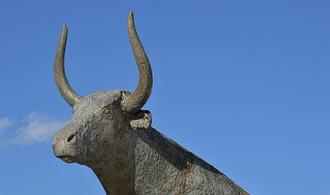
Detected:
[53,12,248,195]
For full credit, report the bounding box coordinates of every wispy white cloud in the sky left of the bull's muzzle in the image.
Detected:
[0,112,66,145]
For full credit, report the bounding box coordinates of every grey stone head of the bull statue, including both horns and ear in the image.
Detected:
[53,12,152,163]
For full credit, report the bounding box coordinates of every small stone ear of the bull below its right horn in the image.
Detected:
[130,110,152,129]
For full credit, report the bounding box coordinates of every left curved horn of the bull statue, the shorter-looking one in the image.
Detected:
[54,25,81,107]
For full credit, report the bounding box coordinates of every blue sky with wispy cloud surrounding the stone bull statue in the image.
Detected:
[0,0,330,195]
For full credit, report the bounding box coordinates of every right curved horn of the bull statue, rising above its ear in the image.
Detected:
[122,12,152,113]
